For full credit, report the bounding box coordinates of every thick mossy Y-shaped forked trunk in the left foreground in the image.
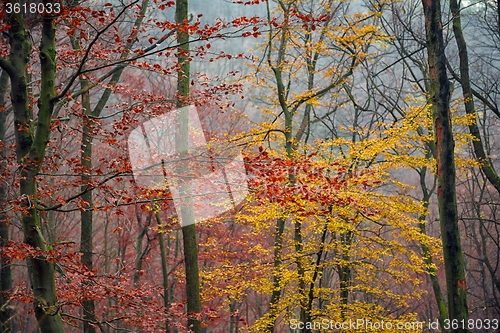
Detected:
[0,3,64,333]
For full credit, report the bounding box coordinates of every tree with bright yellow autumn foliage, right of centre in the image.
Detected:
[236,2,448,332]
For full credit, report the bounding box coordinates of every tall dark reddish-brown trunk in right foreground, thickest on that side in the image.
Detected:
[422,0,469,333]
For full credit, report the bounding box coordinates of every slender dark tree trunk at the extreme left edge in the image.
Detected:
[0,70,13,333]
